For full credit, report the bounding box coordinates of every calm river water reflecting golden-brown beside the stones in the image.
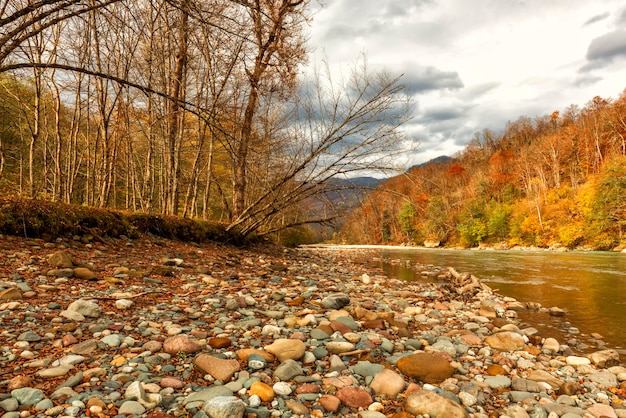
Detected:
[382,249,626,354]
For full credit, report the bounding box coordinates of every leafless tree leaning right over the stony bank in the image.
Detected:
[229,57,410,234]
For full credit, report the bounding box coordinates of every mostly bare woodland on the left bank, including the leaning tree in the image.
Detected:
[0,0,410,242]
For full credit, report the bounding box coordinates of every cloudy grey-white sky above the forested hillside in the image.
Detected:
[311,0,626,165]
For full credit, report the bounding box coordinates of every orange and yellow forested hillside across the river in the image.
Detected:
[336,91,626,250]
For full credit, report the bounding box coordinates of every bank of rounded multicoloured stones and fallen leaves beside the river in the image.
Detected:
[0,236,626,418]
